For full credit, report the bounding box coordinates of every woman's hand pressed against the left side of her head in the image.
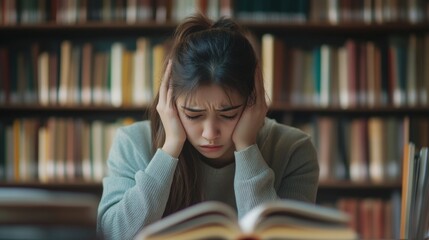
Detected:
[156,59,186,158]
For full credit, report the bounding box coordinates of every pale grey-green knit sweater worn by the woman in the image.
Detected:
[97,118,319,240]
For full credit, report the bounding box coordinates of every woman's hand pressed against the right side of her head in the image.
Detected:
[232,65,268,151]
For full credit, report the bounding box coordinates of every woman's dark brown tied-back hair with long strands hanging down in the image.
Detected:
[150,14,257,216]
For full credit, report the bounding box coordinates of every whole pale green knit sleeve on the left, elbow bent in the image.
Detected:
[97,126,178,239]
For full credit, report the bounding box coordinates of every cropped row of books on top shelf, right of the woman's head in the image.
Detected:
[233,0,429,24]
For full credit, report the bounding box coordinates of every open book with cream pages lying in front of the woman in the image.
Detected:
[135,200,358,240]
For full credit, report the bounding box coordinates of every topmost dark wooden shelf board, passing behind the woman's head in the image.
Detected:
[0,21,429,39]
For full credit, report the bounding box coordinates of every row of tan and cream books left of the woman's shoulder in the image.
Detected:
[0,118,133,183]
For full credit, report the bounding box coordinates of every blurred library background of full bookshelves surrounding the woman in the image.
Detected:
[0,0,429,239]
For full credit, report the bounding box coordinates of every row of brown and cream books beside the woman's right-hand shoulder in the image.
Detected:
[283,116,429,183]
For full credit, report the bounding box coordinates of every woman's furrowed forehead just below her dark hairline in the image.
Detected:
[177,85,243,107]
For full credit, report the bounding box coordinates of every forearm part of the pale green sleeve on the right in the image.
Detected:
[234,144,278,218]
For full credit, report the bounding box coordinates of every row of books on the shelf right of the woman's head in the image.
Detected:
[261,34,429,108]
